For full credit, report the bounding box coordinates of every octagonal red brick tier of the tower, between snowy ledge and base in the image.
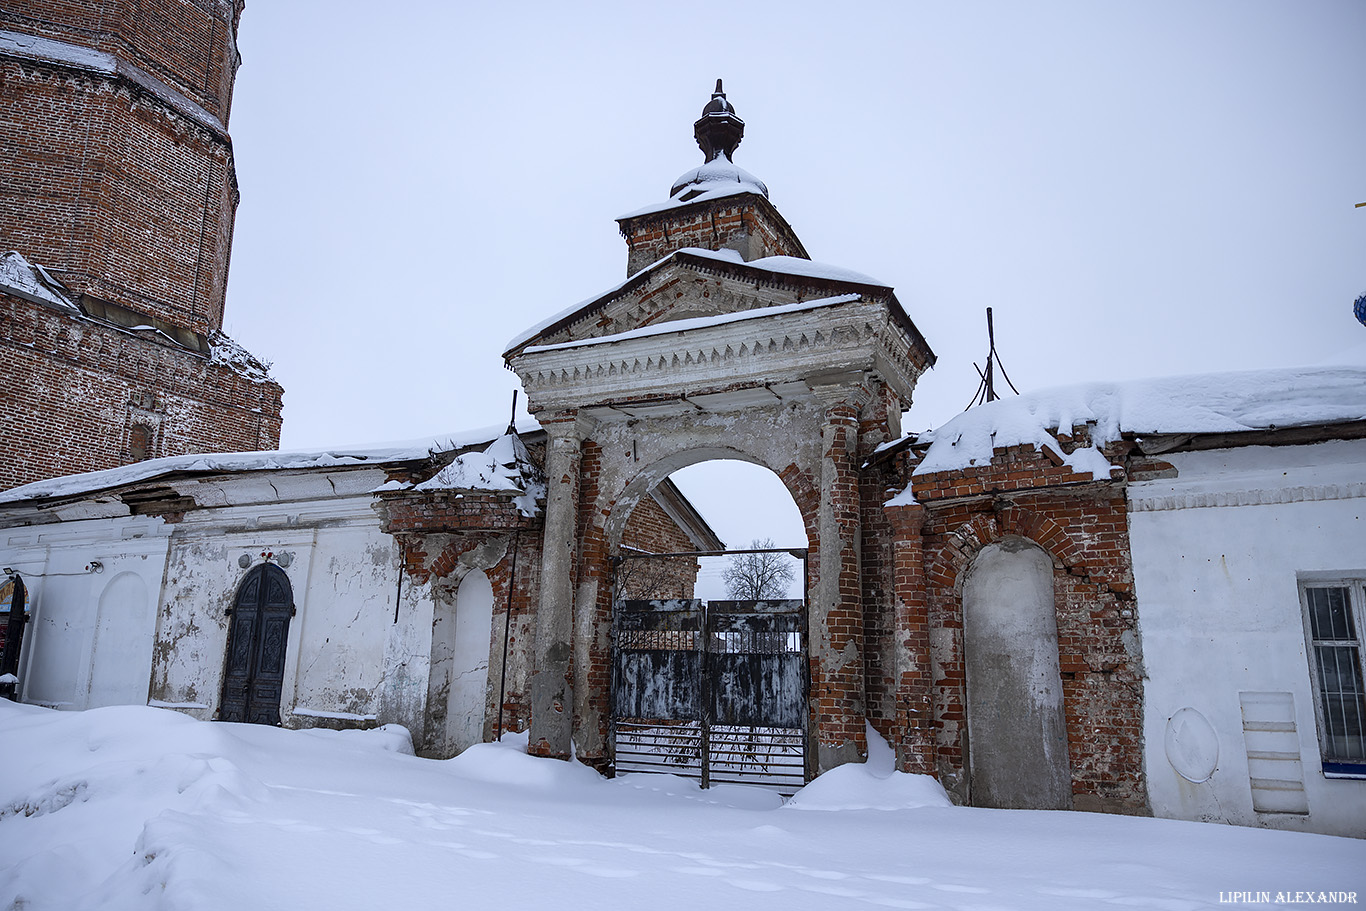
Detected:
[0,60,236,335]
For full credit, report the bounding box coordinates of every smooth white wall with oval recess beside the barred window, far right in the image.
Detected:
[1130,440,1366,836]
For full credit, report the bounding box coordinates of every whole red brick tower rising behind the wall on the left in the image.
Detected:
[0,0,283,489]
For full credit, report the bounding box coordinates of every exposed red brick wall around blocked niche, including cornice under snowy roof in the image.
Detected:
[870,440,1146,813]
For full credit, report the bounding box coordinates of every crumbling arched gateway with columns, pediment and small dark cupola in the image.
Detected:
[504,83,934,772]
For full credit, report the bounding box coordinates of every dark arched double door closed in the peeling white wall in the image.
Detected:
[219,563,294,724]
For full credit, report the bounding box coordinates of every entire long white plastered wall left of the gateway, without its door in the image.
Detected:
[0,470,445,736]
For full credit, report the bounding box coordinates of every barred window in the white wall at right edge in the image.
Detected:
[1300,579,1366,777]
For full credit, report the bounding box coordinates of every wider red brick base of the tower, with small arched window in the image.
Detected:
[0,294,283,489]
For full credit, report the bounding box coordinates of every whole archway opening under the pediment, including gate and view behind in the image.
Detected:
[612,459,809,792]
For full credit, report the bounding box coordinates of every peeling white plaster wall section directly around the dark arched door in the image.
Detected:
[153,510,404,727]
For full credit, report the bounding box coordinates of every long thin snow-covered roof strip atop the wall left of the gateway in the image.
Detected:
[0,419,541,505]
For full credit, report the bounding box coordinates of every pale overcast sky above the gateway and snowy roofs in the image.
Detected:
[218,0,1366,549]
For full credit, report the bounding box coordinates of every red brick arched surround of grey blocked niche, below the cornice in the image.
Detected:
[897,494,1146,813]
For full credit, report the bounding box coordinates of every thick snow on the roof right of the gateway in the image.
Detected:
[915,366,1366,477]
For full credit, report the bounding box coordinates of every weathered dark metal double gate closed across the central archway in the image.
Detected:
[612,550,809,794]
